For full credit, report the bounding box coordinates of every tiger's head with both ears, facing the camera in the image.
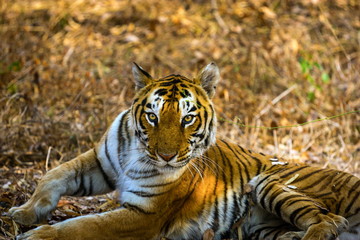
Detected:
[131,63,220,169]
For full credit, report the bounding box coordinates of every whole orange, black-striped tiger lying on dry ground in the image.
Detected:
[9,63,360,240]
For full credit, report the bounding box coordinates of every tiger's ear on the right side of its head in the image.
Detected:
[195,62,220,98]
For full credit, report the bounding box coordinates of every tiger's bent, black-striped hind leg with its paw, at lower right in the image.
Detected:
[253,174,348,240]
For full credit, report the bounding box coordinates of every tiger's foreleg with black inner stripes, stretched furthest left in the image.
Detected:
[9,149,114,225]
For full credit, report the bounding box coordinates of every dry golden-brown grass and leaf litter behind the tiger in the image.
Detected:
[0,0,360,238]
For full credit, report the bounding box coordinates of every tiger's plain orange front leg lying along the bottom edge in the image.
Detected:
[17,208,162,240]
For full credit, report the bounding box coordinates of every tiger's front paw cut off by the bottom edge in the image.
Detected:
[16,225,59,240]
